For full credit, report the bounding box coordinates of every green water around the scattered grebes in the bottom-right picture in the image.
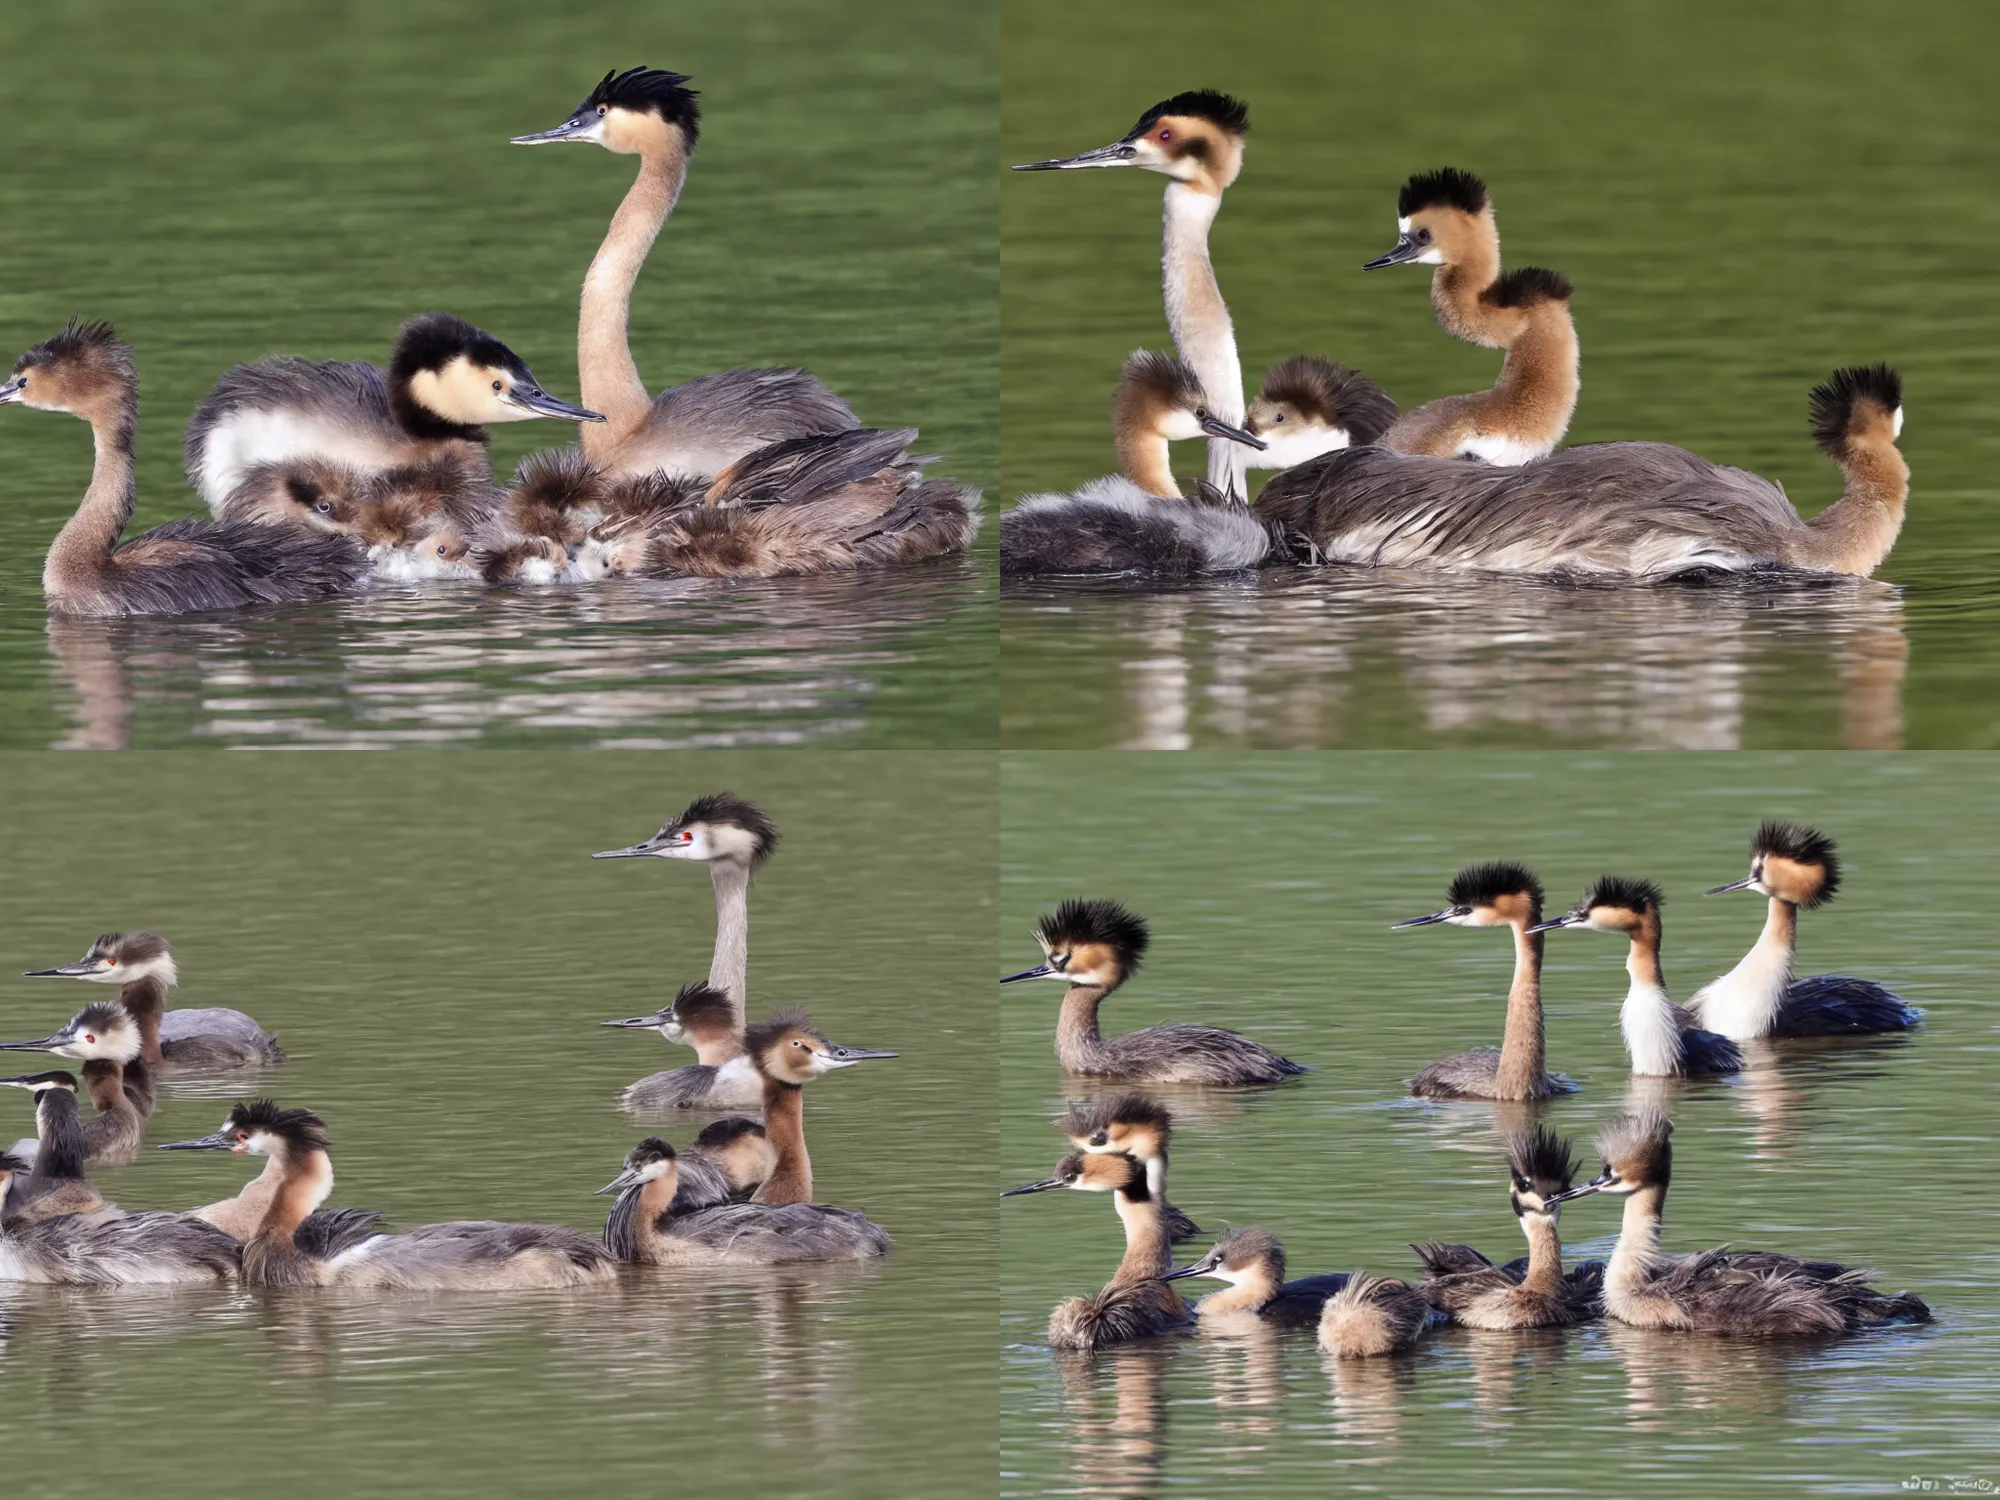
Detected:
[998,754,2000,1498]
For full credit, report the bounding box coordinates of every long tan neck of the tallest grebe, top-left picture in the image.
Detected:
[576,132,688,462]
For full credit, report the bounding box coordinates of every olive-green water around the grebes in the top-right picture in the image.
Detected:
[1000,0,2000,750]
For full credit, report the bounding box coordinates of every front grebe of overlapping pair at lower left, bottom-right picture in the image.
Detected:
[1000,1152,1194,1350]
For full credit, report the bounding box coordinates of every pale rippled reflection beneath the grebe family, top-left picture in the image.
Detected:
[48,564,982,750]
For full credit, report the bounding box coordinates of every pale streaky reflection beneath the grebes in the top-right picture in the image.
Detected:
[1002,568,1910,750]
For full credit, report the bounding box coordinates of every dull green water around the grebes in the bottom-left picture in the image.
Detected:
[0,752,996,1500]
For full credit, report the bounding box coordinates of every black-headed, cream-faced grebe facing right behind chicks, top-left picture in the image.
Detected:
[182,312,604,520]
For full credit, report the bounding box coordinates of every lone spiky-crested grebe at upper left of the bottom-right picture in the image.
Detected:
[1000,900,1306,1086]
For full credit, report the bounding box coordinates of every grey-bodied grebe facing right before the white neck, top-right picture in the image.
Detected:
[1000,350,1270,578]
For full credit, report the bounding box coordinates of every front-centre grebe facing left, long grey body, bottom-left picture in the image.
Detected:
[160,1100,618,1292]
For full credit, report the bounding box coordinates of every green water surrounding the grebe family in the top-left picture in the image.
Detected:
[0,0,998,748]
